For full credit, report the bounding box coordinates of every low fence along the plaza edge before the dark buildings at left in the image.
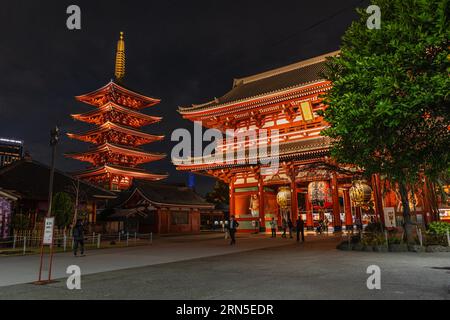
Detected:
[0,232,153,255]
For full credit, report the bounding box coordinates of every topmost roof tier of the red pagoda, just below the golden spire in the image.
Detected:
[75,80,161,110]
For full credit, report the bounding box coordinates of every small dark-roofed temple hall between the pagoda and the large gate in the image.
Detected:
[105,180,218,234]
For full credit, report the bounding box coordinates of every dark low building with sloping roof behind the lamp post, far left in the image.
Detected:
[0,156,117,237]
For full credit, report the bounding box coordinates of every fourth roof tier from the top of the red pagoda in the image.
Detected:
[65,142,166,166]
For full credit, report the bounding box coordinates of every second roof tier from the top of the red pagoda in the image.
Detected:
[71,102,162,128]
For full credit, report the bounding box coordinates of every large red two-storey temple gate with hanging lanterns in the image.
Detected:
[174,52,437,232]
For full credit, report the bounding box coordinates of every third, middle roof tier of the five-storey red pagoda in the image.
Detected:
[67,121,164,146]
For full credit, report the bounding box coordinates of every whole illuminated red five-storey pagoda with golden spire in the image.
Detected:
[66,32,167,190]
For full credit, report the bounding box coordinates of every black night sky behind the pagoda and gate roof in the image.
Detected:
[0,0,368,193]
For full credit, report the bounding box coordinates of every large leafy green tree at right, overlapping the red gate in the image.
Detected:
[323,0,450,241]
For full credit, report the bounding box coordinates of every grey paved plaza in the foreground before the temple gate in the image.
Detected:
[0,234,450,300]
